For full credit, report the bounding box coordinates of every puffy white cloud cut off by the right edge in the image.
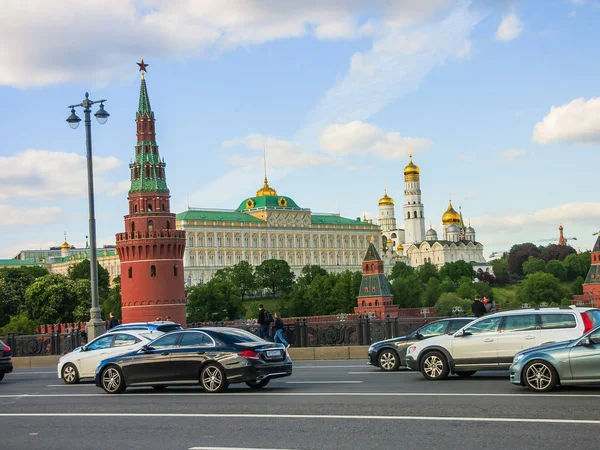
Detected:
[532,97,600,144]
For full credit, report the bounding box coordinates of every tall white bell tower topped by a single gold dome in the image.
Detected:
[404,153,425,245]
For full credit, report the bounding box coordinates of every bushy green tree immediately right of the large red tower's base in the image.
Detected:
[187,279,245,322]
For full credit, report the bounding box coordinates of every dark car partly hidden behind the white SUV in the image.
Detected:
[367,317,475,372]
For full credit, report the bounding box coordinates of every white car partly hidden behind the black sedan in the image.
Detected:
[57,330,164,384]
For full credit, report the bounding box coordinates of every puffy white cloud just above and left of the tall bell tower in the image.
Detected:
[319,121,431,159]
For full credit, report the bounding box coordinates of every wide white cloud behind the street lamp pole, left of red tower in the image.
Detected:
[0,149,128,200]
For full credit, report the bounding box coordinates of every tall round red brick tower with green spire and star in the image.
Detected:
[117,60,186,326]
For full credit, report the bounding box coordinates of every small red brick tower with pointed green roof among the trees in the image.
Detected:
[354,238,398,319]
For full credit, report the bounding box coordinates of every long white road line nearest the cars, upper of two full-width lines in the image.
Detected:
[0,392,600,400]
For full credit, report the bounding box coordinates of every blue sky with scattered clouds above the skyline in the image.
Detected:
[0,0,600,258]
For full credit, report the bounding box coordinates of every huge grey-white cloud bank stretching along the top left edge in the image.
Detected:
[0,0,445,87]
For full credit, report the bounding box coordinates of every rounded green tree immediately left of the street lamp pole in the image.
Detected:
[25,274,84,323]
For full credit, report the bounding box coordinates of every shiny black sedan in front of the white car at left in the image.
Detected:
[96,327,292,394]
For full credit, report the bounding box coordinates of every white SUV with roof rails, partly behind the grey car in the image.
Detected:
[406,306,600,380]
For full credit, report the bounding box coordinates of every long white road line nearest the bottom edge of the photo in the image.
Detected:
[0,412,600,425]
